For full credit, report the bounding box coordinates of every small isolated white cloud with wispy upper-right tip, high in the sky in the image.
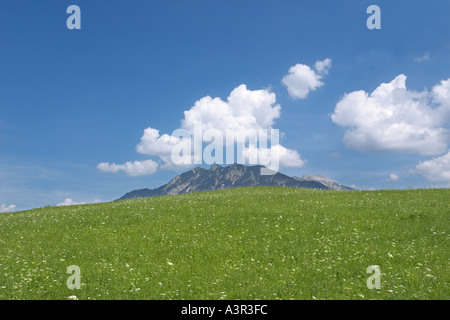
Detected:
[281,58,331,99]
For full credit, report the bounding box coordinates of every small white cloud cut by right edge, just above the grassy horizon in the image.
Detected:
[413,151,450,183]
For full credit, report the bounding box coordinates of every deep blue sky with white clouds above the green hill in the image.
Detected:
[0,0,450,211]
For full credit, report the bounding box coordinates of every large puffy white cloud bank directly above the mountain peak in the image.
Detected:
[97,83,306,176]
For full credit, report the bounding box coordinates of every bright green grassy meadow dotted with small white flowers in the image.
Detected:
[0,187,450,300]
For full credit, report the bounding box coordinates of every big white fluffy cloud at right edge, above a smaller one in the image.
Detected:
[331,74,450,155]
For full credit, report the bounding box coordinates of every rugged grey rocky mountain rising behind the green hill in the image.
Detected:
[118,164,352,200]
